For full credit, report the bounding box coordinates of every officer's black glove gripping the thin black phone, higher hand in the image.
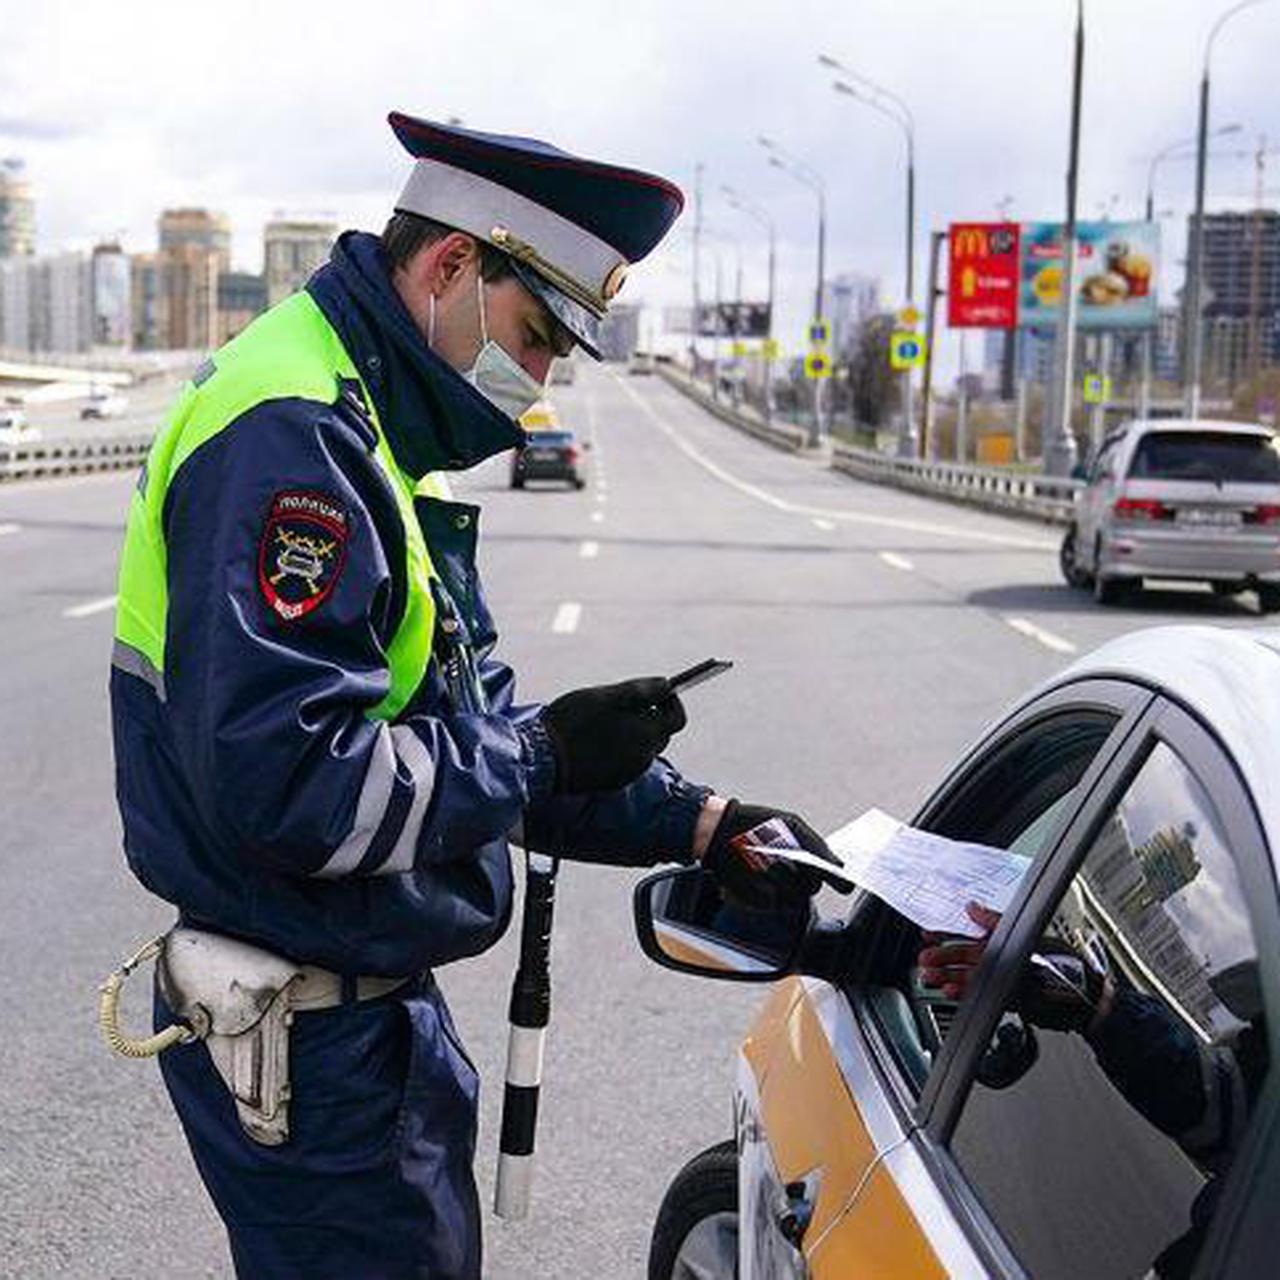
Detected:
[543,676,687,794]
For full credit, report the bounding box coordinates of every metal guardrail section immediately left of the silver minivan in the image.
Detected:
[831,444,1082,525]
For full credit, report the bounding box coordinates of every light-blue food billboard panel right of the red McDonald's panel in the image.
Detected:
[1018,223,1160,329]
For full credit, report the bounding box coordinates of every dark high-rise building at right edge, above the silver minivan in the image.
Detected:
[1187,209,1280,383]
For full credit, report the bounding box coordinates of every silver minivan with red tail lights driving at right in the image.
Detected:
[1061,419,1280,613]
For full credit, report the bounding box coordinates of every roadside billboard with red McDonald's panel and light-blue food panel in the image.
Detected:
[947,223,1160,329]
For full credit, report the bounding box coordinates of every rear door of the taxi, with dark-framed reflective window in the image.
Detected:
[890,700,1280,1280]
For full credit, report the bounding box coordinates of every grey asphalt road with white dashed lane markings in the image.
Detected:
[0,370,1256,1280]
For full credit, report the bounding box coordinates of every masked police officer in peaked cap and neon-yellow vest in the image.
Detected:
[111,114,822,1280]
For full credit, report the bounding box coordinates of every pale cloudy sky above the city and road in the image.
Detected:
[0,0,1280,368]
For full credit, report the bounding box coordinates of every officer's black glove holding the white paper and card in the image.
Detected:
[703,800,851,911]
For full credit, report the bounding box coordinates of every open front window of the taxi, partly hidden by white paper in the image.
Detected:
[859,710,1116,1093]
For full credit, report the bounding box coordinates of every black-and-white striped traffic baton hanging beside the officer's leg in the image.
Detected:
[493,854,559,1221]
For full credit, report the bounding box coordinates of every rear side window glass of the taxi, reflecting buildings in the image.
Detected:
[951,742,1267,1280]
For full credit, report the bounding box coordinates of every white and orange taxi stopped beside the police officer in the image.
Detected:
[635,627,1280,1280]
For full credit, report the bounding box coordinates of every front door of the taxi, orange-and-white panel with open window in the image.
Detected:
[739,681,1152,1280]
